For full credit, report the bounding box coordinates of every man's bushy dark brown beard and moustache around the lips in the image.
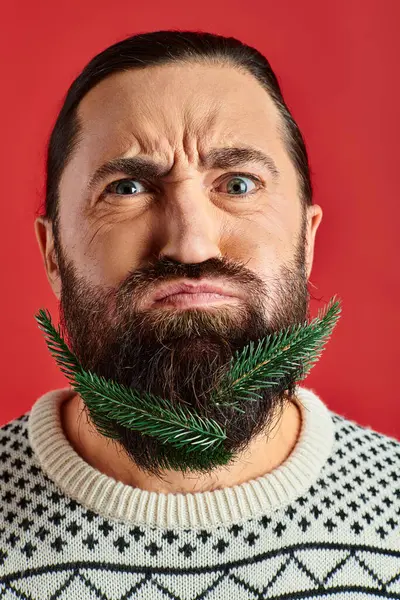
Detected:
[56,220,309,476]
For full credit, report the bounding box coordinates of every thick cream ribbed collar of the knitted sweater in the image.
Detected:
[28,387,334,529]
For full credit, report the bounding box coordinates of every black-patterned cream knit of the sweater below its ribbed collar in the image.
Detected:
[0,406,400,600]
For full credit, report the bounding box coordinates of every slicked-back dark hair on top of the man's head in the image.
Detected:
[44,30,312,237]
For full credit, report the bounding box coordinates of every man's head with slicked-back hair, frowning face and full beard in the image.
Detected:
[35,31,322,472]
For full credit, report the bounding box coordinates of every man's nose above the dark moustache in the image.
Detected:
[159,182,221,263]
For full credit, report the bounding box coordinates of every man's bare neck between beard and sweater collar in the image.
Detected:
[61,394,301,493]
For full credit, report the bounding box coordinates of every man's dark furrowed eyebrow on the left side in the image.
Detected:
[88,156,170,192]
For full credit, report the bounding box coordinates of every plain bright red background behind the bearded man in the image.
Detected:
[0,0,400,438]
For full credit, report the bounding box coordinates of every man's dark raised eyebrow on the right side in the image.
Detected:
[203,146,280,181]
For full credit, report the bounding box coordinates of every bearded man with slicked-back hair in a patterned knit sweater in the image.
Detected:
[0,31,400,600]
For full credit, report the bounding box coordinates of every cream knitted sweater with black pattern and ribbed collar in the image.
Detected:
[0,387,400,600]
